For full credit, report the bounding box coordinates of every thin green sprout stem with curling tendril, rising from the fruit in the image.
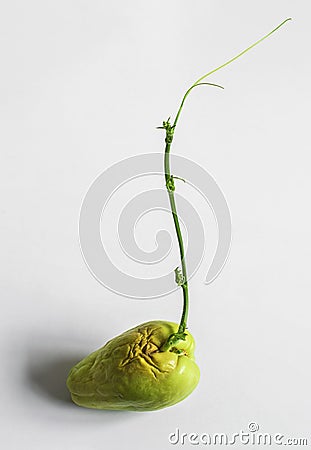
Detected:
[158,18,291,351]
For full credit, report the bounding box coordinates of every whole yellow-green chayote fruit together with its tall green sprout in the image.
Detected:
[67,19,290,411]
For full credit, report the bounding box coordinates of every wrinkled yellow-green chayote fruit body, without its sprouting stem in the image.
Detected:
[67,320,200,411]
